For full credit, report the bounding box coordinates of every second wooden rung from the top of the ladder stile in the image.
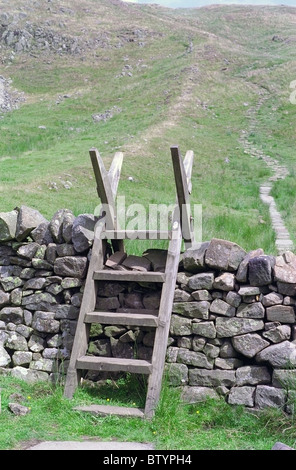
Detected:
[93,269,165,282]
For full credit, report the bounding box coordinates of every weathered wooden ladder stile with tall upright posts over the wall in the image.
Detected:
[64,147,193,418]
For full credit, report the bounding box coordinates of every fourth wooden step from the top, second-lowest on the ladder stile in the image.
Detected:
[76,356,152,374]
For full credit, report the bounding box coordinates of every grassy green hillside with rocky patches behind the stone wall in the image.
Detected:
[0,0,296,252]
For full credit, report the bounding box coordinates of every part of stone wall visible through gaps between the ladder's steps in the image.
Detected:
[88,249,167,380]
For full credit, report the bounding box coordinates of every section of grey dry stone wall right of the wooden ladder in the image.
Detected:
[167,239,296,408]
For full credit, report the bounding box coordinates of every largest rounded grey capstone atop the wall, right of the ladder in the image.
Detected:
[205,238,246,271]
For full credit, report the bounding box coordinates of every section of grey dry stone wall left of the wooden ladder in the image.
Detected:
[0,206,95,381]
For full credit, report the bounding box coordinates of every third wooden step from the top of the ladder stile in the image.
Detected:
[84,312,158,328]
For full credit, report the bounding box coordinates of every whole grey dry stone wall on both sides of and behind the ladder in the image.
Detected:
[0,206,296,411]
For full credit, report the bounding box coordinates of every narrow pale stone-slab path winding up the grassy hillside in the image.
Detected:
[239,94,294,254]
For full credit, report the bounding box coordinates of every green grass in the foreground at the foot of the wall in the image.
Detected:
[0,377,296,450]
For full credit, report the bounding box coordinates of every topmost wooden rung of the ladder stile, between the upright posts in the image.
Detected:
[100,230,173,240]
